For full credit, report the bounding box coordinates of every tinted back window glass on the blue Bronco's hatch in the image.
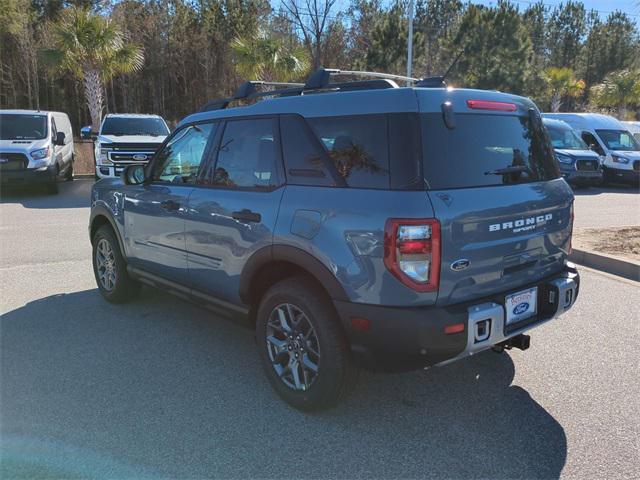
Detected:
[421,113,559,189]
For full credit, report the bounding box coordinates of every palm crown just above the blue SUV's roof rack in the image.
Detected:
[231,33,309,82]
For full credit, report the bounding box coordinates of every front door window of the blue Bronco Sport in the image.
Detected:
[153,123,216,183]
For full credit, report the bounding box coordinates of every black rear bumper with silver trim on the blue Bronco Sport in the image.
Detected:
[334,263,580,372]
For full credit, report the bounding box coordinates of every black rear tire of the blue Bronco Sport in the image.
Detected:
[256,276,358,411]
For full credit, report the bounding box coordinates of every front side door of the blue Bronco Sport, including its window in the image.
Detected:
[123,123,217,285]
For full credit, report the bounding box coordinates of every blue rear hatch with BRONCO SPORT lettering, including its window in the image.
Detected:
[419,90,573,305]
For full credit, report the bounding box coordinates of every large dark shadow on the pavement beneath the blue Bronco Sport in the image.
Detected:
[0,289,567,479]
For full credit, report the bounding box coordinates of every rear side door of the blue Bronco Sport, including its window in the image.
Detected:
[185,117,284,304]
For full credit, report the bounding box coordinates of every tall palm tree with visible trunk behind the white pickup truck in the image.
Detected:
[42,7,144,131]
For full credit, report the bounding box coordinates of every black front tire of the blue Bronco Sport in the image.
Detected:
[92,225,140,303]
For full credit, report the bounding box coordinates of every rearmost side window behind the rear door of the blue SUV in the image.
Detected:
[308,115,389,189]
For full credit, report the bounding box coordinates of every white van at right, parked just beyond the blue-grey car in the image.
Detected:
[543,113,640,185]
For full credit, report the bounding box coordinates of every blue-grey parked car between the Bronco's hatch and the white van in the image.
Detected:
[543,118,602,187]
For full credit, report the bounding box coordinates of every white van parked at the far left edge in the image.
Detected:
[0,110,75,193]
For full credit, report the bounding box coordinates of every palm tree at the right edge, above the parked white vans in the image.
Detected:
[591,70,640,120]
